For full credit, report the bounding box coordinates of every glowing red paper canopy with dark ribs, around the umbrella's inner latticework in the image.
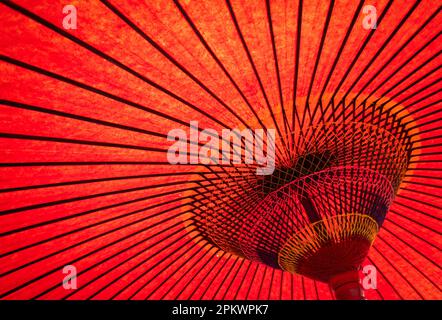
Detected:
[0,0,442,299]
